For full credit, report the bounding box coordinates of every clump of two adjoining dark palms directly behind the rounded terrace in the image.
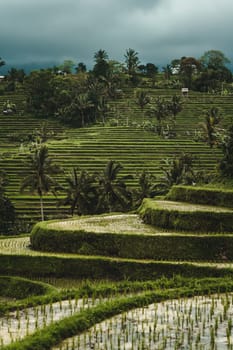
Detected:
[58,160,132,215]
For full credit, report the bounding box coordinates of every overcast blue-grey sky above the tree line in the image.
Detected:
[0,0,233,68]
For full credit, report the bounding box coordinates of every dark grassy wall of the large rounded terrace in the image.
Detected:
[31,216,233,261]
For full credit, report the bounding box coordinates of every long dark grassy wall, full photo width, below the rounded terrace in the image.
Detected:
[0,254,233,281]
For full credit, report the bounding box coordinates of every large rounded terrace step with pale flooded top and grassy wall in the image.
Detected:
[19,214,233,262]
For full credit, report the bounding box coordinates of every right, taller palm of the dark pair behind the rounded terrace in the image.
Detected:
[98,160,132,212]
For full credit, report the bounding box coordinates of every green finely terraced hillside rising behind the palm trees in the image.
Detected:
[0,88,233,227]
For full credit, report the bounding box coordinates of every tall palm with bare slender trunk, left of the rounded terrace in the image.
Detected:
[20,145,61,221]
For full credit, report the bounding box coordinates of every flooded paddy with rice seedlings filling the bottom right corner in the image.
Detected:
[53,294,233,350]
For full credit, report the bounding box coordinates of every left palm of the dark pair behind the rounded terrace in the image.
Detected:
[59,168,98,216]
